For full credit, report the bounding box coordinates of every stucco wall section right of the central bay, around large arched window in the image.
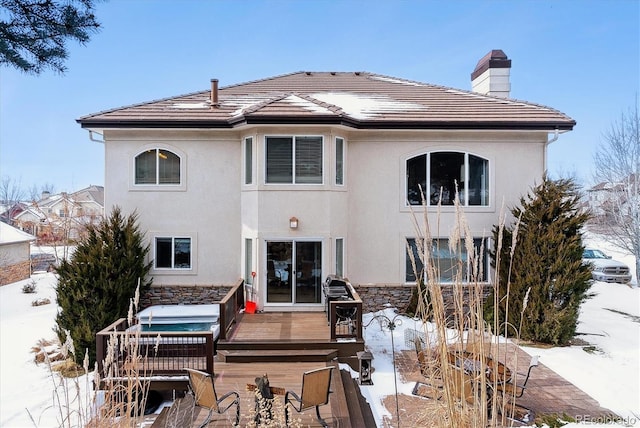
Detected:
[346,133,546,284]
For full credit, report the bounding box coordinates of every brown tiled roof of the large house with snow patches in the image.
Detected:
[77,72,575,131]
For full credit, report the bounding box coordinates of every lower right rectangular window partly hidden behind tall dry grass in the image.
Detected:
[405,238,488,283]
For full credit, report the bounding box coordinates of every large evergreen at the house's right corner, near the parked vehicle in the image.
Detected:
[485,177,591,345]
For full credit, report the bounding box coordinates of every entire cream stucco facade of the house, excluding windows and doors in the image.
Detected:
[105,127,547,300]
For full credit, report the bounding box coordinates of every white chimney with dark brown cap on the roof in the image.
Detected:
[471,49,511,98]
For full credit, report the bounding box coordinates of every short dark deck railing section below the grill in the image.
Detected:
[328,282,363,341]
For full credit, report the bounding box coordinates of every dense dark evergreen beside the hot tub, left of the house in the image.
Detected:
[56,207,151,364]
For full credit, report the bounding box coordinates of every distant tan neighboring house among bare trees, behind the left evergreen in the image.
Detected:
[14,185,104,243]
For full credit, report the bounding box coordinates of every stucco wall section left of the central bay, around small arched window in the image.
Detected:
[105,131,241,285]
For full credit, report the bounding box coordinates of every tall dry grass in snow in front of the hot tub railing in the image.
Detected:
[34,288,160,428]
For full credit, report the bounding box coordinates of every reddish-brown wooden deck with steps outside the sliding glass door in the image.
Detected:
[138,312,372,428]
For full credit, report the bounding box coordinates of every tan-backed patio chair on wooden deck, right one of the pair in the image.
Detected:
[284,367,333,427]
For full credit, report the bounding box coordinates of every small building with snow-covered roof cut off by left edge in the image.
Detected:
[0,222,36,286]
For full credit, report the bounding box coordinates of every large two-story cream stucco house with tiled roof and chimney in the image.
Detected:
[78,50,575,310]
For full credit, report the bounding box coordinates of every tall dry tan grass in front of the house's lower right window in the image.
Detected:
[407,191,526,428]
